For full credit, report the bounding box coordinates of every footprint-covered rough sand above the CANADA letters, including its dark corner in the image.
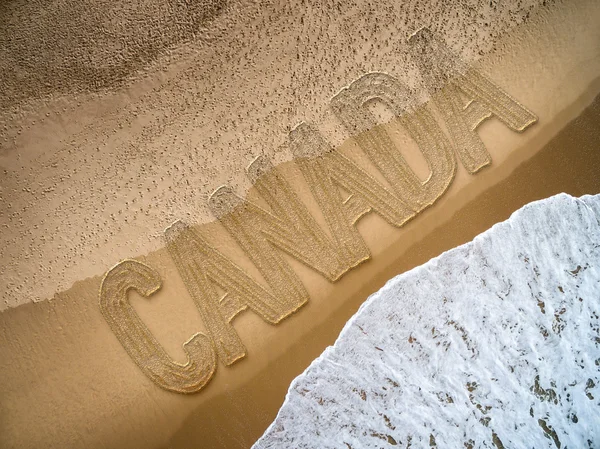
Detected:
[0,0,552,309]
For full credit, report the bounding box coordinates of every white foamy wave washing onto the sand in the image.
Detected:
[254,194,600,449]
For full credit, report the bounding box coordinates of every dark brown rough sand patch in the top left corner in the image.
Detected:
[0,0,227,110]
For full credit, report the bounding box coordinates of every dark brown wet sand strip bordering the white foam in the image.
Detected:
[164,86,600,448]
